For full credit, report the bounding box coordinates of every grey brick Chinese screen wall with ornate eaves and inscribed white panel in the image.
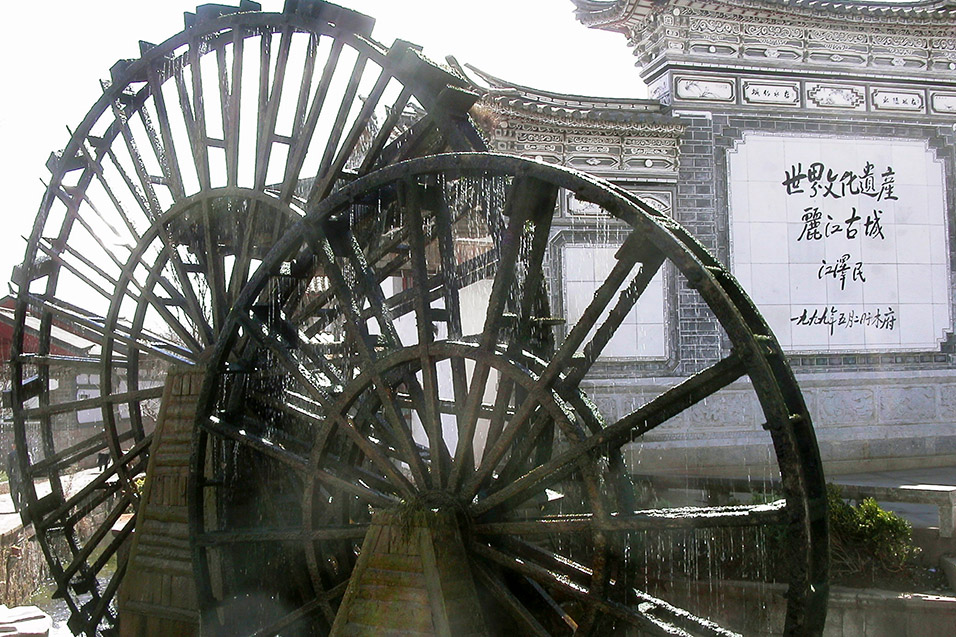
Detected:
[483,0,956,473]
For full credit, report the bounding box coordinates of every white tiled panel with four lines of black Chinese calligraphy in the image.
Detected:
[728,134,952,352]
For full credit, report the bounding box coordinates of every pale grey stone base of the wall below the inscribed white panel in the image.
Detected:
[587,370,956,479]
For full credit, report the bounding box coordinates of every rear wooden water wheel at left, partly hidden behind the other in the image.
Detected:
[5,0,483,636]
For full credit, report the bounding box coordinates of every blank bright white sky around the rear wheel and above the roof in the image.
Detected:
[0,0,646,292]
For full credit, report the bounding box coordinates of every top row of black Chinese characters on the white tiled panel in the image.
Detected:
[781,161,898,201]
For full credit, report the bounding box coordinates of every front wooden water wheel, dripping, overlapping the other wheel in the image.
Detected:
[190,153,828,635]
